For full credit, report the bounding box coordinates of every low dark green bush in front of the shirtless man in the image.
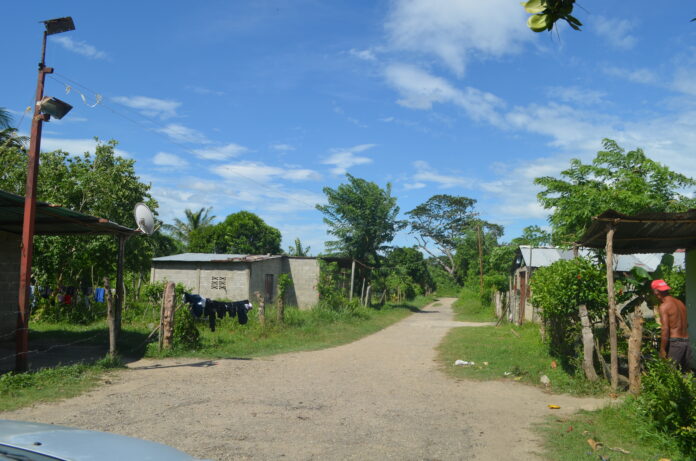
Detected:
[637,360,696,457]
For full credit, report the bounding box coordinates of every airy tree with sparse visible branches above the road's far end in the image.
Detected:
[406,194,476,278]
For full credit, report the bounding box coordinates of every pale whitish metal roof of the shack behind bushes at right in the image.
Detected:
[517,245,686,272]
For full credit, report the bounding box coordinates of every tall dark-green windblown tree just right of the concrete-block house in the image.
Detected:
[317,174,405,264]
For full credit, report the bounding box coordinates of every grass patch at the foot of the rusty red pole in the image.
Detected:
[0,358,122,411]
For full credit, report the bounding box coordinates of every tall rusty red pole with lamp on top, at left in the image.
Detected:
[15,17,75,372]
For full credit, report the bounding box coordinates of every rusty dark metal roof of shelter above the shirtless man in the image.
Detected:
[580,209,696,254]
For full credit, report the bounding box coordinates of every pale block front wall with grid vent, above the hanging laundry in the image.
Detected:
[150,261,249,301]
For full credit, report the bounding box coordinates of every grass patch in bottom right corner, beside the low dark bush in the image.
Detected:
[538,399,688,461]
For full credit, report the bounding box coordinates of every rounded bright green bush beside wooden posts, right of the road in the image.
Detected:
[530,258,608,367]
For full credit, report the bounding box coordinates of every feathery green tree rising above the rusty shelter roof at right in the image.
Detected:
[534,139,696,244]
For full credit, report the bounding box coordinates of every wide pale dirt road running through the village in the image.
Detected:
[0,298,602,460]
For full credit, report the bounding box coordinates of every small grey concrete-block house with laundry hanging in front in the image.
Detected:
[150,253,319,309]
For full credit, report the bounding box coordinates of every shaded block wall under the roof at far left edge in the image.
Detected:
[0,232,21,342]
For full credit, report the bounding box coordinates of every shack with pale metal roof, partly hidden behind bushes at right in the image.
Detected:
[496,245,686,323]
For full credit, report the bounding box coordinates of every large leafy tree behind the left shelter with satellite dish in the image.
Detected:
[0,140,157,285]
